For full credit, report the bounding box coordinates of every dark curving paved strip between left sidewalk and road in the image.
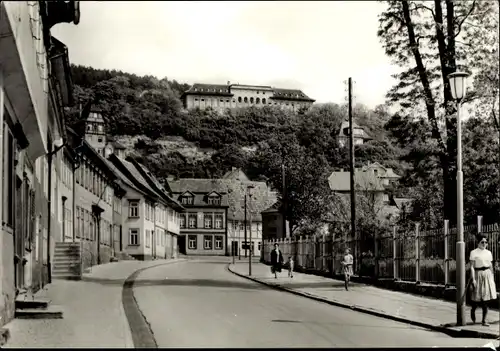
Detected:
[122,260,187,349]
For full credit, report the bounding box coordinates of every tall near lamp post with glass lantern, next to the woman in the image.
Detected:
[448,72,469,326]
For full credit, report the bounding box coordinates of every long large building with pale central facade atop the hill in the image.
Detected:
[181,82,315,112]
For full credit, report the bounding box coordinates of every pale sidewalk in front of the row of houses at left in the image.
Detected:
[4,259,185,348]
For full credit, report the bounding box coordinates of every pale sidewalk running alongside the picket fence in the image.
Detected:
[229,263,499,338]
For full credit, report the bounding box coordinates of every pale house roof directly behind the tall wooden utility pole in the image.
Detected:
[328,169,384,191]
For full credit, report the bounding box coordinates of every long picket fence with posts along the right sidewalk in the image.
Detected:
[261,216,500,286]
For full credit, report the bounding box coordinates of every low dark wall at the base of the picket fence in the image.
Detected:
[261,260,500,309]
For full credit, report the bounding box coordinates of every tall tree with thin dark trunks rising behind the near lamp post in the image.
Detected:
[378,0,498,226]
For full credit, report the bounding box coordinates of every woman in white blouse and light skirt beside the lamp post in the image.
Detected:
[469,235,497,326]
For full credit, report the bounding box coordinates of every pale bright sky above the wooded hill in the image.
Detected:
[52,1,396,108]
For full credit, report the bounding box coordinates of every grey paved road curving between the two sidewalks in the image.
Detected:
[134,259,496,348]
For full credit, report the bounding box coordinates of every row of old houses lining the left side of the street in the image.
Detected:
[0,1,184,326]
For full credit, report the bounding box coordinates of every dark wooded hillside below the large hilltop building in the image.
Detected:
[68,51,498,236]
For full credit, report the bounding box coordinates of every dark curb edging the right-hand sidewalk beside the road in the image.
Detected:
[226,263,500,339]
